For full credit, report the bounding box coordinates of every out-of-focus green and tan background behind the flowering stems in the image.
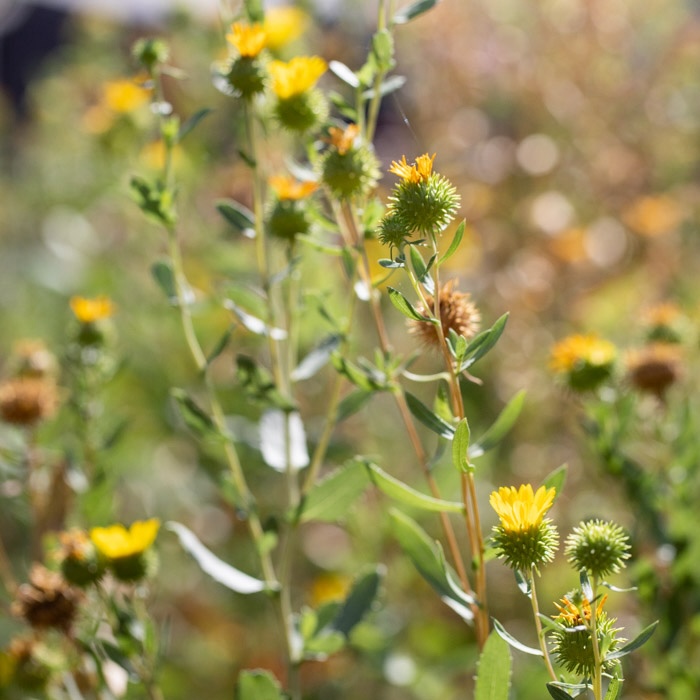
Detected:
[0,0,700,700]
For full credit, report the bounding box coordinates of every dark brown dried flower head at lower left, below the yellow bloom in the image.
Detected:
[12,564,82,633]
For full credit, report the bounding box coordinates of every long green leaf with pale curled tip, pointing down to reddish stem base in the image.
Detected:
[390,509,474,622]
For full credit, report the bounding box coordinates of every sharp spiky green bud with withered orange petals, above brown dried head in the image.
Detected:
[379,153,460,245]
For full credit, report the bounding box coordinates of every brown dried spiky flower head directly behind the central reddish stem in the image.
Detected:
[409,280,481,348]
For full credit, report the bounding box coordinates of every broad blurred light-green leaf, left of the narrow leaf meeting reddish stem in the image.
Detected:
[298,459,369,523]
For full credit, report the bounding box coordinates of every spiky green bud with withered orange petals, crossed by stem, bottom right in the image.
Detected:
[550,591,625,677]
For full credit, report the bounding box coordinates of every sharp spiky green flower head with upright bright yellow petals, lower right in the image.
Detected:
[489,484,559,571]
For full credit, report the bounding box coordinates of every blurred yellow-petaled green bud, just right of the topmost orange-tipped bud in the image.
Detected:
[267,56,328,132]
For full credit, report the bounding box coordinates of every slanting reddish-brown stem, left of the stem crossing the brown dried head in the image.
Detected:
[332,202,476,600]
